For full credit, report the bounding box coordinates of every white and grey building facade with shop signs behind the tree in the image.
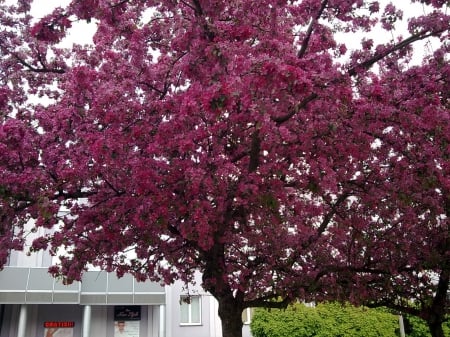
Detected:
[0,247,250,337]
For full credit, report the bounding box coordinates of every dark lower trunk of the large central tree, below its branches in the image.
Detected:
[217,296,243,337]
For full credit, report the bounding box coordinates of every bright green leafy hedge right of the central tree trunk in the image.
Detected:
[251,303,450,337]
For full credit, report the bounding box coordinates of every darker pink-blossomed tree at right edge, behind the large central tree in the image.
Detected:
[316,51,450,337]
